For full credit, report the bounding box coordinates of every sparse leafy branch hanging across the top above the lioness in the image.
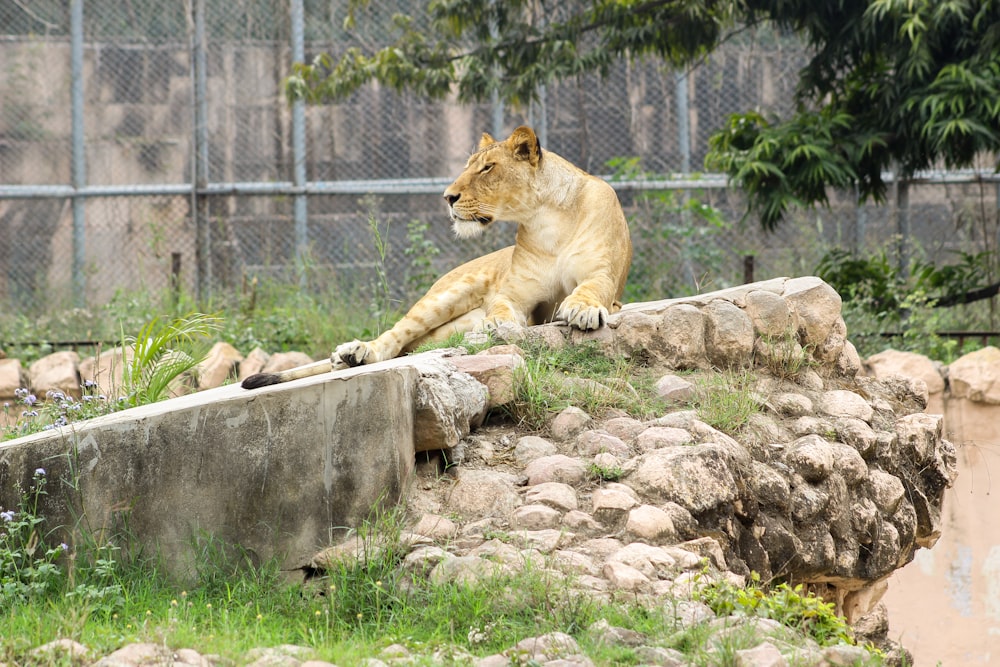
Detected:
[288,0,736,102]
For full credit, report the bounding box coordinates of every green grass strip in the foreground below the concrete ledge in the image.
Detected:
[0,471,880,666]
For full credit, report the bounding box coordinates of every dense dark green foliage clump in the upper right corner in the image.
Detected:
[707,0,1000,228]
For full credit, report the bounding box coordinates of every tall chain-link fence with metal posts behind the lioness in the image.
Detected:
[0,0,997,320]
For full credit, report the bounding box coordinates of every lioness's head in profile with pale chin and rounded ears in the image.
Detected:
[444,127,542,238]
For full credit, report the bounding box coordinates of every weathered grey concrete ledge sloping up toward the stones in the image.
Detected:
[0,363,420,577]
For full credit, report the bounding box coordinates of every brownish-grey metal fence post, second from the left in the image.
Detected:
[191,0,212,303]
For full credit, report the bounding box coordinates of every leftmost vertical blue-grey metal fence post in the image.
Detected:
[70,0,87,307]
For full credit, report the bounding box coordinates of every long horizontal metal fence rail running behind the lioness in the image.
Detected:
[0,169,1000,200]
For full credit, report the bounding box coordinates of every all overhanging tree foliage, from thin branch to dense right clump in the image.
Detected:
[288,0,1000,229]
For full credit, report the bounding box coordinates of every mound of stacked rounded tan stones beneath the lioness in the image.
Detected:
[376,278,956,648]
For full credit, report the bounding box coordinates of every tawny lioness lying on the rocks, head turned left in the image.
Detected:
[243,127,632,389]
